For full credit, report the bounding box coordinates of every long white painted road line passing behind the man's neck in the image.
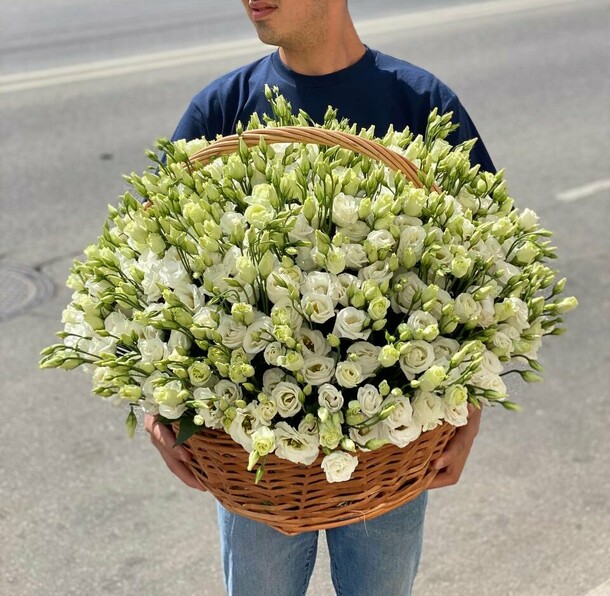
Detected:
[0,0,599,94]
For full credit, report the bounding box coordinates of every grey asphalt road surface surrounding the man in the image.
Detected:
[0,0,610,596]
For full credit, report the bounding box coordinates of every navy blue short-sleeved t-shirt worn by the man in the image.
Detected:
[172,48,495,172]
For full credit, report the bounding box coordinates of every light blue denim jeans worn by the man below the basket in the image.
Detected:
[218,492,427,596]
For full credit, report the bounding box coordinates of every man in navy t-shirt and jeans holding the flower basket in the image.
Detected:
[146,0,484,596]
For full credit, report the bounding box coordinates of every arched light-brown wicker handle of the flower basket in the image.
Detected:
[190,126,440,192]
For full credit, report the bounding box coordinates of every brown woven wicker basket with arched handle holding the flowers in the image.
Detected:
[169,126,455,535]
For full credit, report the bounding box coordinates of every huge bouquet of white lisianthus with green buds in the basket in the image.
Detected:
[41,91,576,482]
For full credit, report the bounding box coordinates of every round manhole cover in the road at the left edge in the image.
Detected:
[0,263,53,321]
